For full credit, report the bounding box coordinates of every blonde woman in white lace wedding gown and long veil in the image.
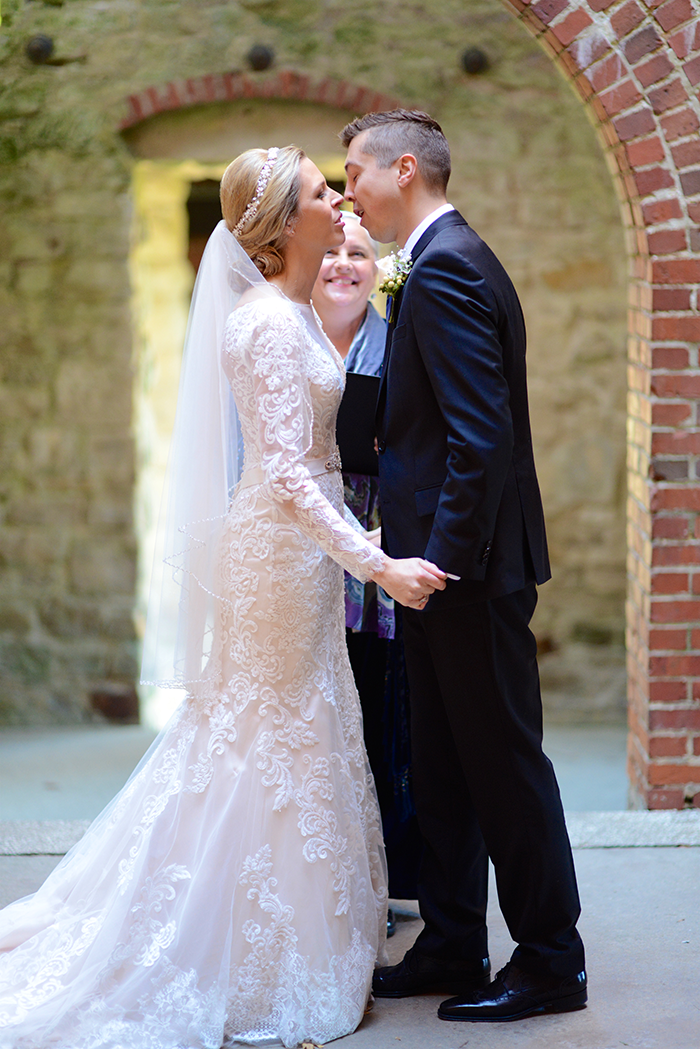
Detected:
[0,146,445,1049]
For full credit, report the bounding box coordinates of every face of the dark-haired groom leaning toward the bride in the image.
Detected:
[345,131,403,244]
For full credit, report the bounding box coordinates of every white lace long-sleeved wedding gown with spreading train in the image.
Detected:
[0,297,386,1049]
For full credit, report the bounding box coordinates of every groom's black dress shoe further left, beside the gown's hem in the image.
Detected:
[372,947,491,998]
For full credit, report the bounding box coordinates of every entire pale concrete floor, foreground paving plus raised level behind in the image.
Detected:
[0,726,700,1049]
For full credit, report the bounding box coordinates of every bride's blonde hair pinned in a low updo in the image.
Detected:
[220,146,306,277]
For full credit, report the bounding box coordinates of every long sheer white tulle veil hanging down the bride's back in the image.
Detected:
[142,220,275,690]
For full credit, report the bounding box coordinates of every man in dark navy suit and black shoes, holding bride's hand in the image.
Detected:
[341,109,587,1021]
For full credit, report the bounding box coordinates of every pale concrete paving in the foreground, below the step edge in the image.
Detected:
[0,848,700,1049]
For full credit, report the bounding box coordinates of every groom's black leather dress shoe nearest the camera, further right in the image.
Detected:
[438,962,588,1023]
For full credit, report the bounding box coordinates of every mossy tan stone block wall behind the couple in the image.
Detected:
[0,0,625,723]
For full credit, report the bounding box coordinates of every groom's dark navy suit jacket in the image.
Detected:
[377,211,550,608]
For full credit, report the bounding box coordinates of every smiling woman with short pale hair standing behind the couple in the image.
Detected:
[313,212,421,918]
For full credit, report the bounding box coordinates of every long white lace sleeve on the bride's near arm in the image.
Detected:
[227,302,384,582]
